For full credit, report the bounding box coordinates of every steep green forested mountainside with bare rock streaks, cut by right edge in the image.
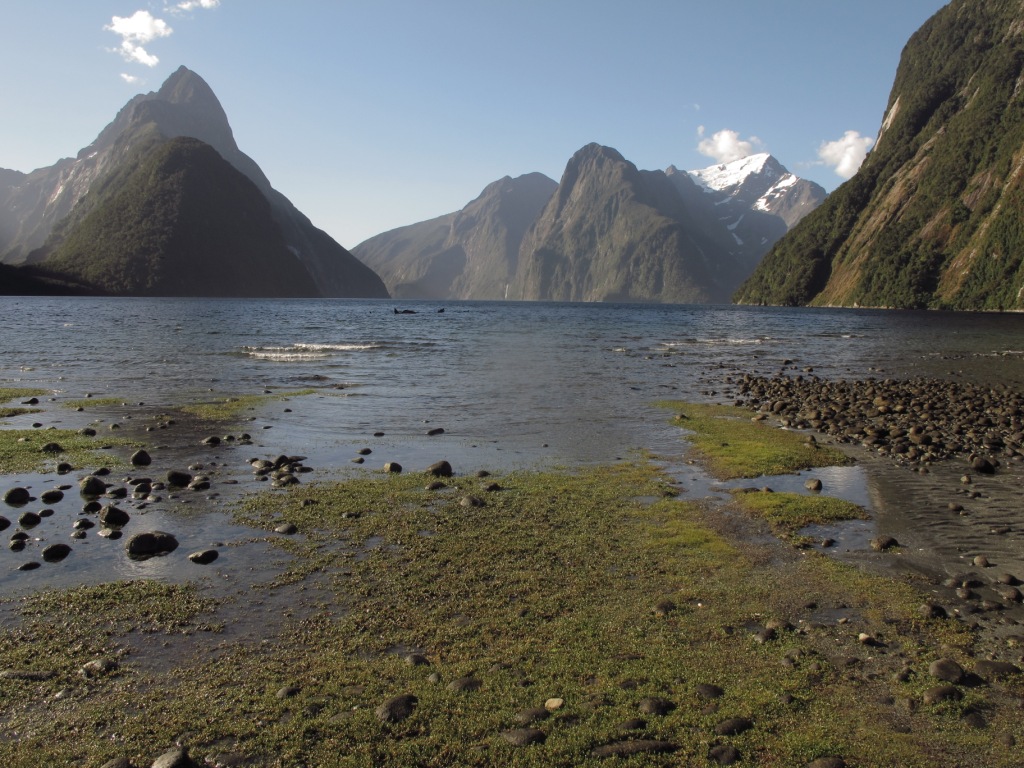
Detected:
[735,0,1024,309]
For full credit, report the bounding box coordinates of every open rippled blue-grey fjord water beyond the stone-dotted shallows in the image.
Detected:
[6,298,1024,469]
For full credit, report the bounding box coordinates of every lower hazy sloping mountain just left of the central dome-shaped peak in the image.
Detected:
[352,173,558,299]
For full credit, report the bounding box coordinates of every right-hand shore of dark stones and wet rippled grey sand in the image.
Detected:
[726,374,1024,646]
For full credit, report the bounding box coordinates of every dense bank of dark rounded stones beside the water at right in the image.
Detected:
[727,375,1024,473]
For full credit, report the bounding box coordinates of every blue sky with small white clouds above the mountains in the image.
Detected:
[0,0,946,248]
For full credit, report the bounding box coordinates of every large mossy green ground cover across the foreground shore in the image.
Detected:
[0,381,1024,768]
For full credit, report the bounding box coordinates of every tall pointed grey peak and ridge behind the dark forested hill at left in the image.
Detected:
[0,67,388,298]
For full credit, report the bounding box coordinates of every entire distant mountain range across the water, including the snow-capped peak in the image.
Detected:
[352,143,825,302]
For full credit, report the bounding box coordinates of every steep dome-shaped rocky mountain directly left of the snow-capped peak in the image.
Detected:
[511,144,736,302]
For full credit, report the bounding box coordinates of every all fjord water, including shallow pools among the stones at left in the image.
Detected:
[6,298,1024,592]
